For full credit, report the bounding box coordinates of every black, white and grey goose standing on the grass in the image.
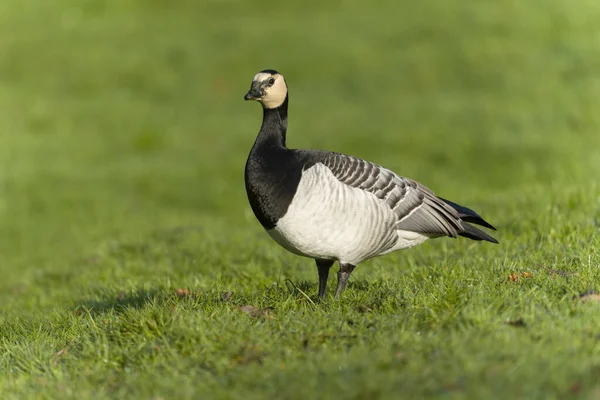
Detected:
[244,69,498,300]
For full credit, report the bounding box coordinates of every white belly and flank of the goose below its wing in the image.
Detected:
[267,164,427,265]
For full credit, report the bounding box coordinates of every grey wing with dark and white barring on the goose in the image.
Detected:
[321,153,467,237]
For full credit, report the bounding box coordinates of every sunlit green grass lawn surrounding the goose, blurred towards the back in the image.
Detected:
[0,0,600,399]
